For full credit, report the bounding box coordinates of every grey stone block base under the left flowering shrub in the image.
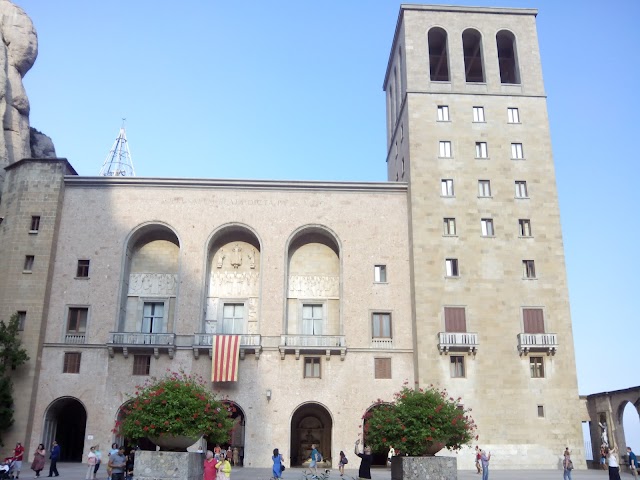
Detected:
[134,450,204,480]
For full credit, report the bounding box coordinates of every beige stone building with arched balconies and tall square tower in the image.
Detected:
[0,1,584,468]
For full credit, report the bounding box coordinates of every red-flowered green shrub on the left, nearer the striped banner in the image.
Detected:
[113,372,233,443]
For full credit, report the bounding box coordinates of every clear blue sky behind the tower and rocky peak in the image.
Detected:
[16,0,640,451]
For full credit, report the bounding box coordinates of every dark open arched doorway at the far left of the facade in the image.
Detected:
[43,397,87,462]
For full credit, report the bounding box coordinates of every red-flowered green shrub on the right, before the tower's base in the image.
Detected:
[363,385,478,456]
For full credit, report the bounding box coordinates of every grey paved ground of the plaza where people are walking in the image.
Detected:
[30,462,616,480]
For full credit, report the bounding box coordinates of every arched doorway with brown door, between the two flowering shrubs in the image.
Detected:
[289,403,333,467]
